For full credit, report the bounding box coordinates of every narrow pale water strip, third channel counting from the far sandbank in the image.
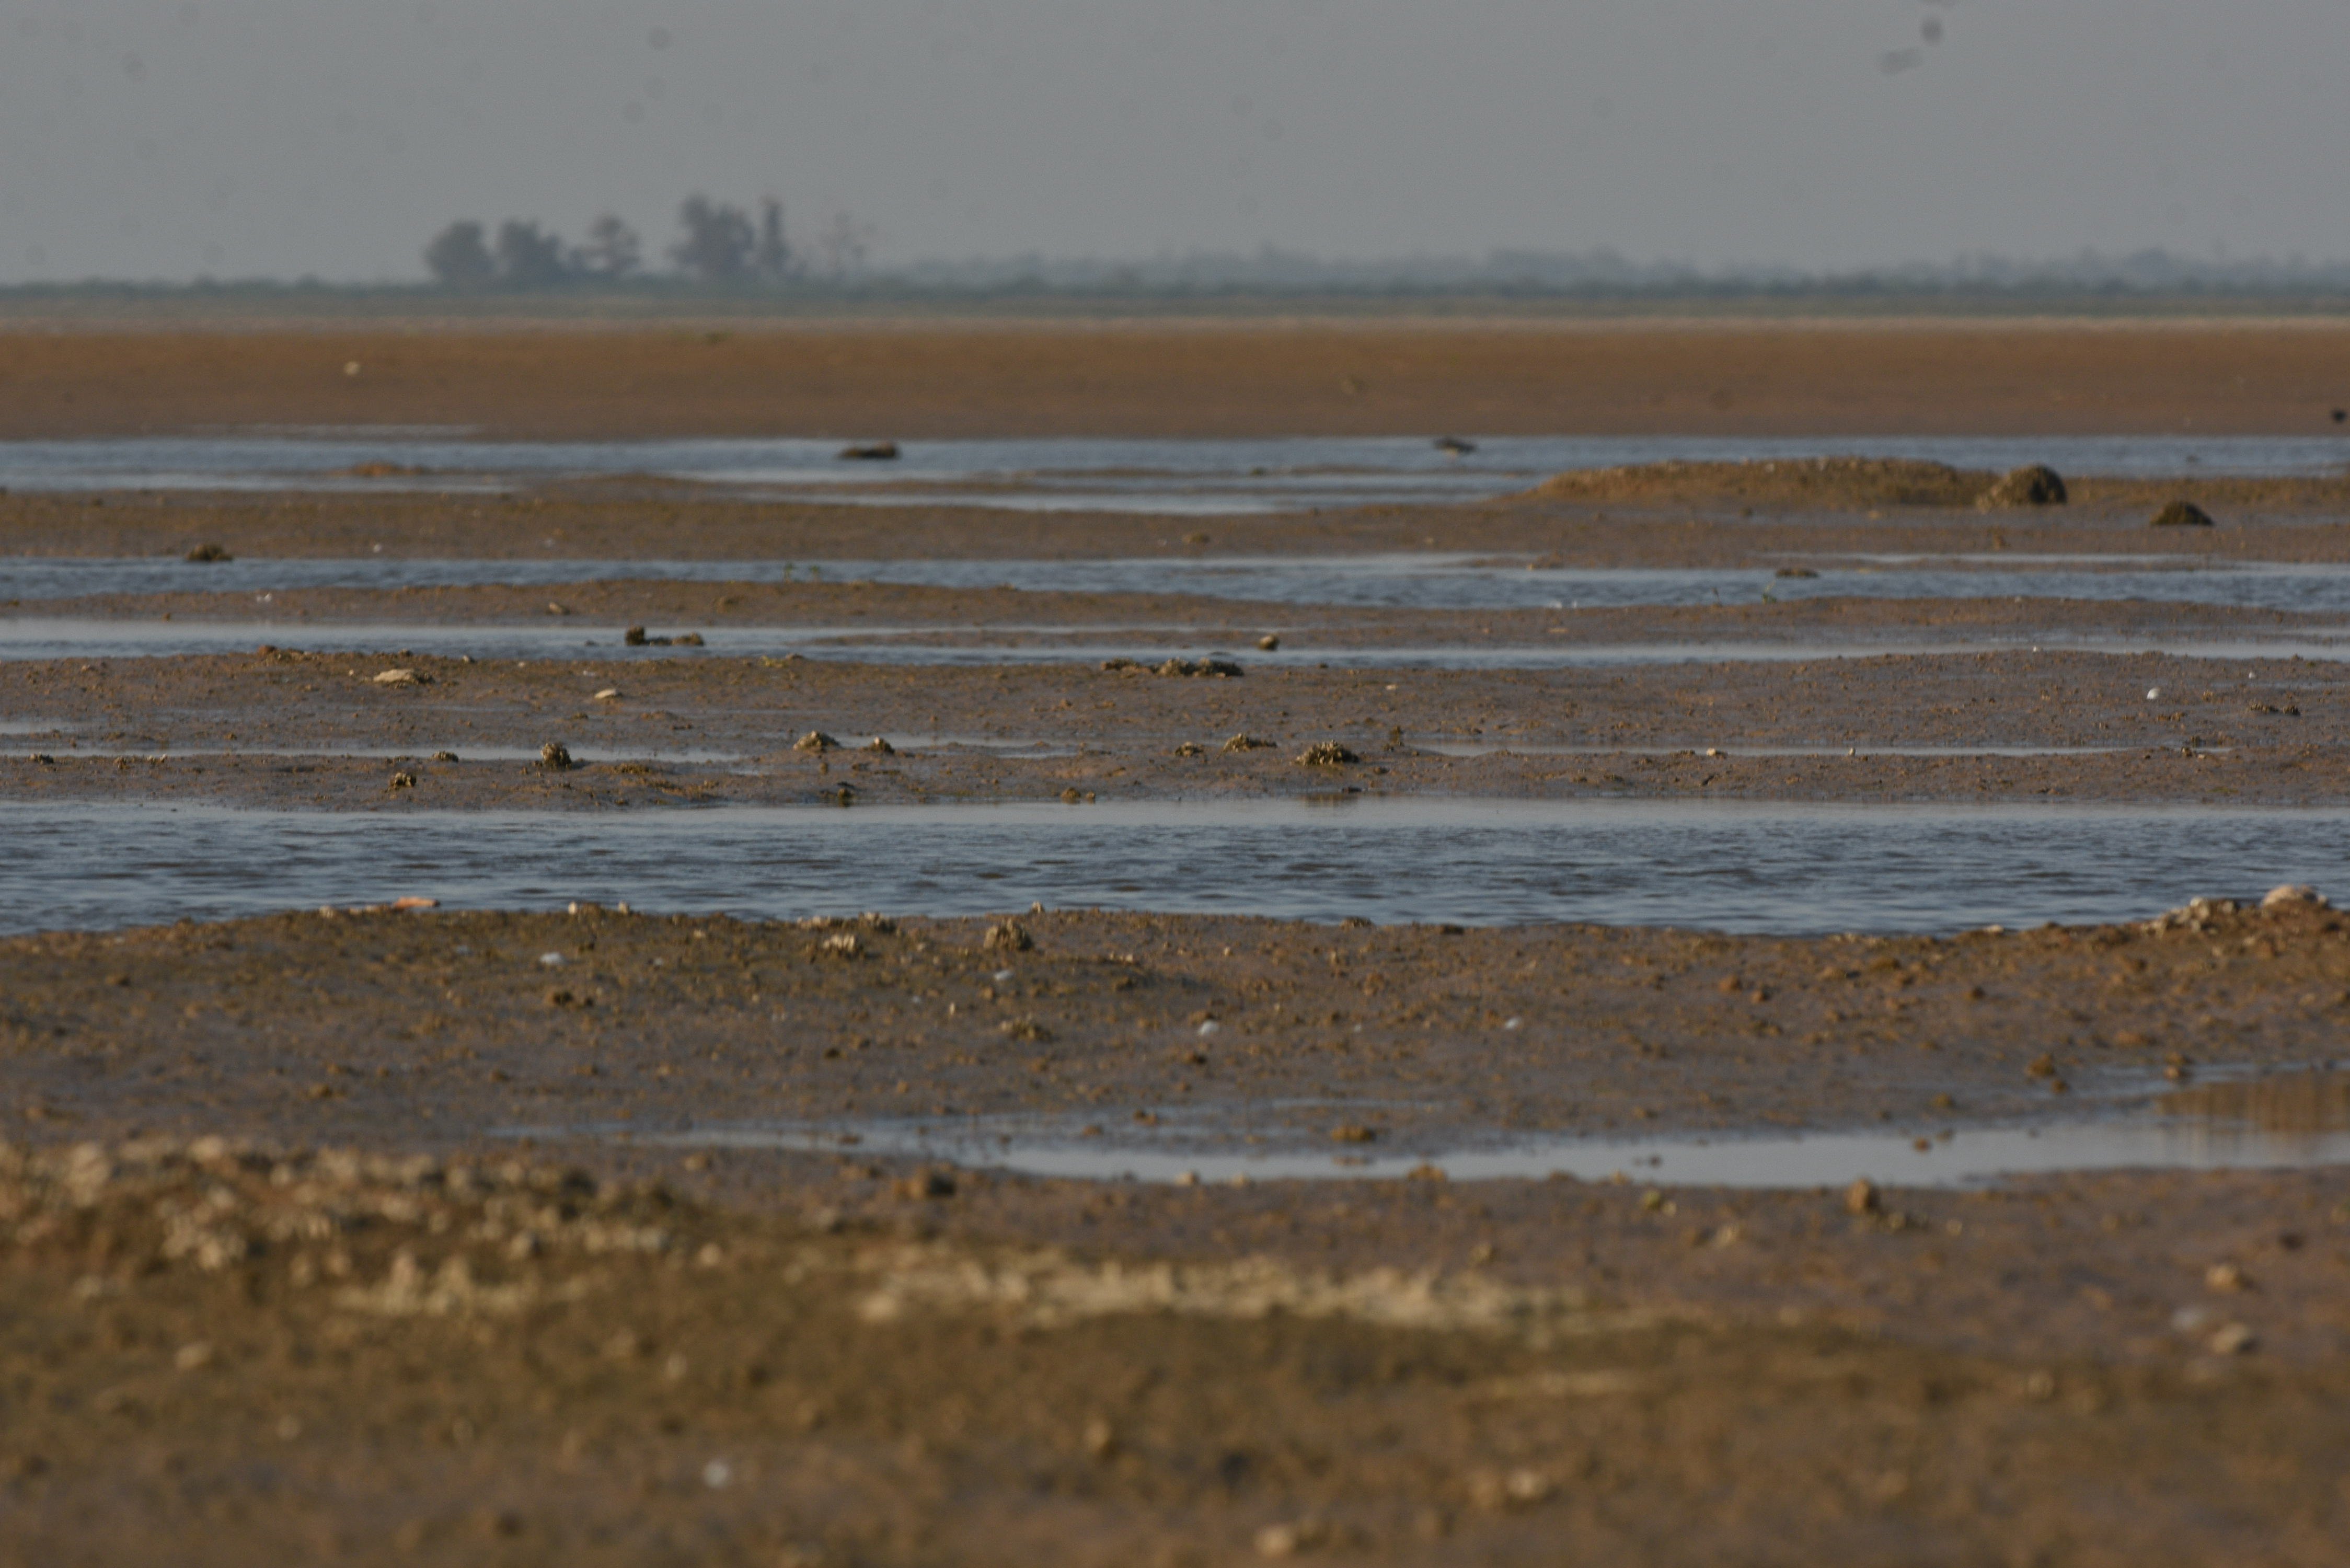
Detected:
[0,616,2350,670]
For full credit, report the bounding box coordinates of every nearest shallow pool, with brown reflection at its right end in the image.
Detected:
[596,1072,2350,1187]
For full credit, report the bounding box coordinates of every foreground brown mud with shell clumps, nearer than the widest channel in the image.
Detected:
[0,905,2350,1563]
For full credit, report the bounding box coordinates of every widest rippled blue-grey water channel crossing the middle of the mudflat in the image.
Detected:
[0,804,2350,933]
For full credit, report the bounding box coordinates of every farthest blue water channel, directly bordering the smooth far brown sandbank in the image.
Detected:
[0,430,2350,515]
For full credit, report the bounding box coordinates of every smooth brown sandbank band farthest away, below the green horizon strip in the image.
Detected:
[0,322,2350,440]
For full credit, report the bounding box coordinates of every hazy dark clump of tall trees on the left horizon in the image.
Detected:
[425,193,872,289]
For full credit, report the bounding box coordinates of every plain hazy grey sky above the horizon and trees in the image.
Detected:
[0,0,2350,280]
